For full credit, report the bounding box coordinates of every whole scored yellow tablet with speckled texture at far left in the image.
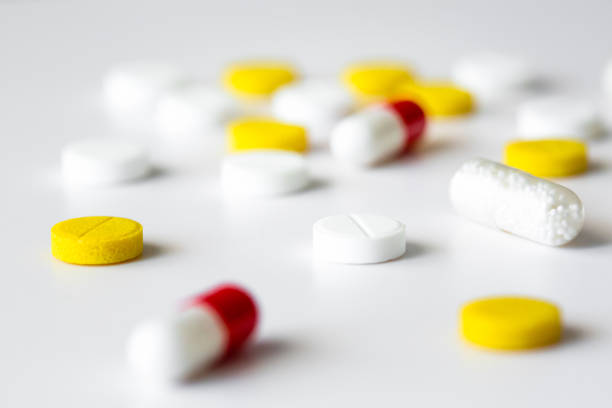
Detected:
[51,217,142,265]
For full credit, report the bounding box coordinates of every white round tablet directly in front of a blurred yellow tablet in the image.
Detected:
[221,150,310,196]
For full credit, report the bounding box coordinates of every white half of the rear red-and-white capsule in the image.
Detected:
[330,105,406,166]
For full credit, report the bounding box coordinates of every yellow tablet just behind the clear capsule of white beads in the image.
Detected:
[504,139,588,177]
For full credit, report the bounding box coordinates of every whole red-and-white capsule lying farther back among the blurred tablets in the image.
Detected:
[330,101,425,166]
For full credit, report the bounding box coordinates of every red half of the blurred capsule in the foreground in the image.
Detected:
[187,285,258,357]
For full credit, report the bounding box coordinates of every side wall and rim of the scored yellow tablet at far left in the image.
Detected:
[51,217,144,265]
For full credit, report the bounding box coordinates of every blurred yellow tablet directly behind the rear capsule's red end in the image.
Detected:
[394,81,474,117]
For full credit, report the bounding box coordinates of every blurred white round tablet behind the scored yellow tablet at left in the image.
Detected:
[62,139,150,186]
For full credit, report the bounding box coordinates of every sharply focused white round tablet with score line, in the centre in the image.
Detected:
[313,214,406,264]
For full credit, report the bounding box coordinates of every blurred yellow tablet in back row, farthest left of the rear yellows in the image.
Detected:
[223,61,298,99]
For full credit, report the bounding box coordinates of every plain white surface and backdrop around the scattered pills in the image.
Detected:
[0,0,612,408]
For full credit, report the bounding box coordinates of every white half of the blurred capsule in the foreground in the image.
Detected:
[126,306,228,381]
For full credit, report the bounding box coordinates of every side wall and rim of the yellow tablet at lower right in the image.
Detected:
[459,296,563,351]
